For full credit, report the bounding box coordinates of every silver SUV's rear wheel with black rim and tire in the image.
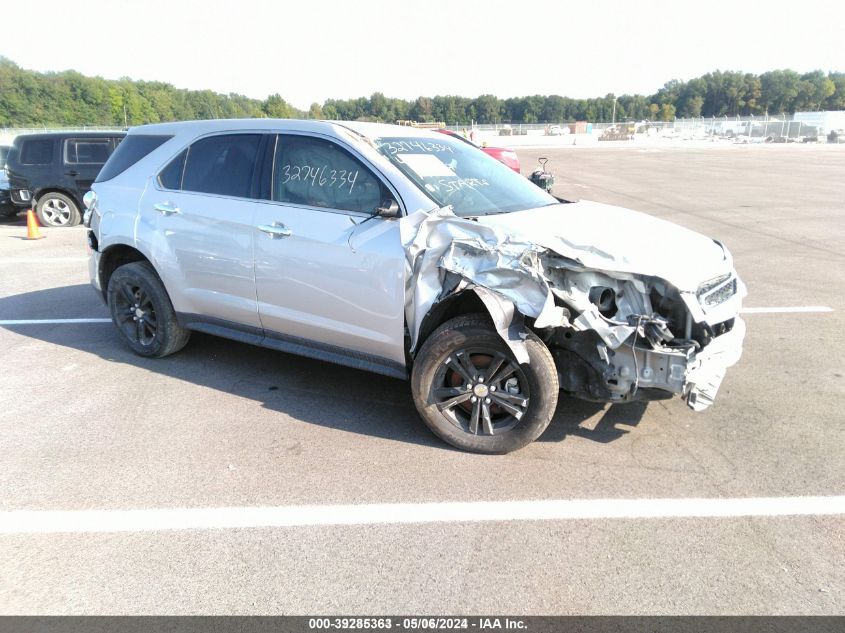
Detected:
[106,262,191,358]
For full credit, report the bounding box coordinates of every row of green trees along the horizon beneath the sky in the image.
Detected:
[0,57,845,127]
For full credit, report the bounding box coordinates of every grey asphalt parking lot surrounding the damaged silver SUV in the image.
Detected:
[0,146,845,615]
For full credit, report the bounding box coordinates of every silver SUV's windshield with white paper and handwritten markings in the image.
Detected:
[376,135,557,217]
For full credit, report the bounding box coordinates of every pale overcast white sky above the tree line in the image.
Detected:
[0,0,845,109]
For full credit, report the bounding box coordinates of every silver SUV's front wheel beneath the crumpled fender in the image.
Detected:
[411,314,559,454]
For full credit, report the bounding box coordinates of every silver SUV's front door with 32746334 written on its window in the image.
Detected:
[255,134,405,375]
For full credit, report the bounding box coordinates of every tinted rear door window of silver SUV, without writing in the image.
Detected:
[182,134,261,198]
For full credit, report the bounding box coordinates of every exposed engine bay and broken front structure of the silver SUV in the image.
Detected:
[540,268,736,409]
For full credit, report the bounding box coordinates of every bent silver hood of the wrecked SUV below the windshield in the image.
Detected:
[478,200,732,292]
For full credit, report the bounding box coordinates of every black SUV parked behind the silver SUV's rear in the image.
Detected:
[6,132,126,226]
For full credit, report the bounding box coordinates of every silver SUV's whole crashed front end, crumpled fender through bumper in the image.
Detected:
[403,205,745,411]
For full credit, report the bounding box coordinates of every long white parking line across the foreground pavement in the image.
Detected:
[0,496,845,534]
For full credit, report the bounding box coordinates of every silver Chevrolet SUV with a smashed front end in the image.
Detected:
[85,119,745,453]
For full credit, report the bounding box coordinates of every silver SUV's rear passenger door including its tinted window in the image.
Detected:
[137,133,272,330]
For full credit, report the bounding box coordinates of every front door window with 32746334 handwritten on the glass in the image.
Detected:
[273,135,384,214]
